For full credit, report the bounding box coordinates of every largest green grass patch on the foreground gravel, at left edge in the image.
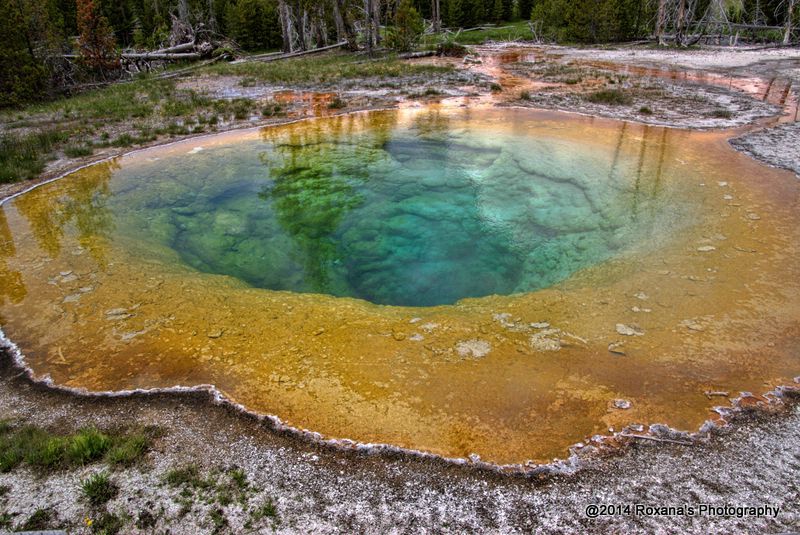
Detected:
[0,422,155,472]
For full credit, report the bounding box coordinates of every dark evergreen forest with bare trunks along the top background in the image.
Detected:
[0,0,800,107]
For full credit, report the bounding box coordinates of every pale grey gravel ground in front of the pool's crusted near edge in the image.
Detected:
[0,352,800,534]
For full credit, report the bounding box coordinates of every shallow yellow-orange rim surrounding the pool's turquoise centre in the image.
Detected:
[0,105,800,463]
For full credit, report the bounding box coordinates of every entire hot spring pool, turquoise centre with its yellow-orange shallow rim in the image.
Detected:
[0,107,800,463]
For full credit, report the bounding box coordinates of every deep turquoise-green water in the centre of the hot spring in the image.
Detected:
[101,110,680,306]
